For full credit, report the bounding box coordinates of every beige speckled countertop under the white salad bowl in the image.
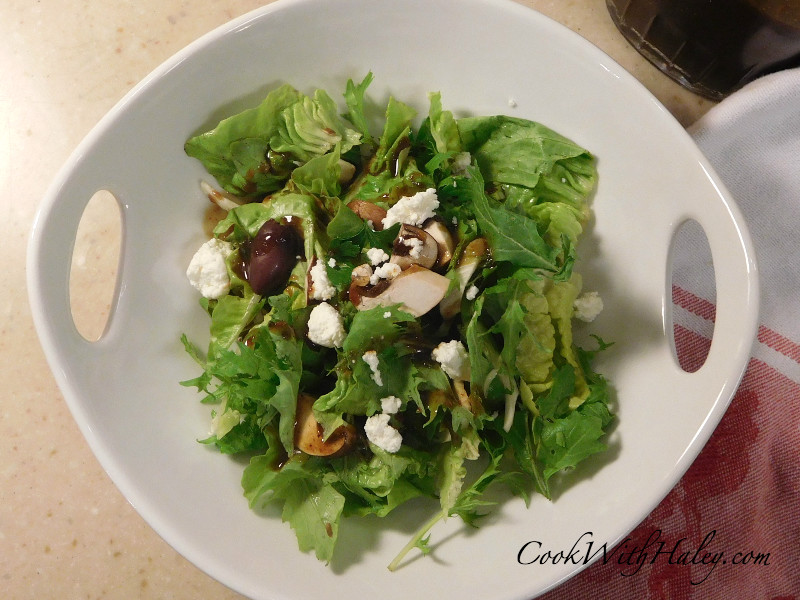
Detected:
[0,0,712,600]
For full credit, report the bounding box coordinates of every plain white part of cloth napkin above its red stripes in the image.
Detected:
[676,69,800,346]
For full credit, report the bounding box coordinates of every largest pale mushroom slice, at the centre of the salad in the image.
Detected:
[350,265,450,317]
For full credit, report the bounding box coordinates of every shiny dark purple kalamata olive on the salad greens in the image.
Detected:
[247,219,301,296]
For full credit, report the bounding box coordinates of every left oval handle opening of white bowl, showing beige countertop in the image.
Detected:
[69,190,122,342]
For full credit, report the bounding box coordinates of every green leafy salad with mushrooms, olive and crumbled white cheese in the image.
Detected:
[182,73,613,569]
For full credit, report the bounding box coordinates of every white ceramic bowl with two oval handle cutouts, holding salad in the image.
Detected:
[29,0,757,600]
